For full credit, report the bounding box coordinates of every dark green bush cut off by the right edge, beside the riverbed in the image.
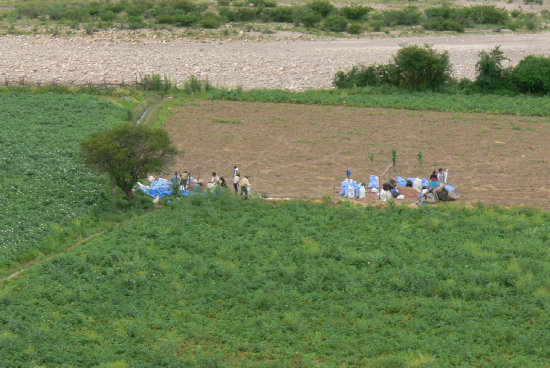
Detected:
[512,55,550,93]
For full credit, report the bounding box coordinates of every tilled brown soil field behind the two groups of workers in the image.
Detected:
[165,101,550,209]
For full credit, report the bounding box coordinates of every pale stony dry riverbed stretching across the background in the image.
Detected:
[0,32,550,90]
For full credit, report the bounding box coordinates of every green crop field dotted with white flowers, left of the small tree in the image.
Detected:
[0,92,124,267]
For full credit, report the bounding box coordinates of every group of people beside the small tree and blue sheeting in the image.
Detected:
[171,165,251,198]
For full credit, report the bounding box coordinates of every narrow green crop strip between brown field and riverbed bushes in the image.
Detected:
[210,87,550,116]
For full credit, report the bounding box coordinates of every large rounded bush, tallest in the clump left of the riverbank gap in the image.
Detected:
[394,45,451,90]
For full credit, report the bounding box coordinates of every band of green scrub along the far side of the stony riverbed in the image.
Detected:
[0,0,548,33]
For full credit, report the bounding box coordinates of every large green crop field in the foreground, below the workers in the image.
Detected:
[0,195,550,367]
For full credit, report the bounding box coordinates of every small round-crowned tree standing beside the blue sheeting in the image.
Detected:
[80,123,177,201]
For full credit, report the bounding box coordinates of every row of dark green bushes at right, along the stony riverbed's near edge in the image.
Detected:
[333,45,550,94]
